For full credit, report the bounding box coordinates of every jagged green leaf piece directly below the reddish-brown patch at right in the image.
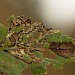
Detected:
[49,55,75,69]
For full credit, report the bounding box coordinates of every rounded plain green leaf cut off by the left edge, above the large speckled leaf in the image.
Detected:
[0,24,8,42]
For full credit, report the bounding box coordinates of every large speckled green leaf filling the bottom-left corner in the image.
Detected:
[0,51,28,75]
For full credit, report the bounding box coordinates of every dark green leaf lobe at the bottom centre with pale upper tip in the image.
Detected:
[31,59,49,75]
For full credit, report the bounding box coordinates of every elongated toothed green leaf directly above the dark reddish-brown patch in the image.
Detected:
[46,32,74,43]
